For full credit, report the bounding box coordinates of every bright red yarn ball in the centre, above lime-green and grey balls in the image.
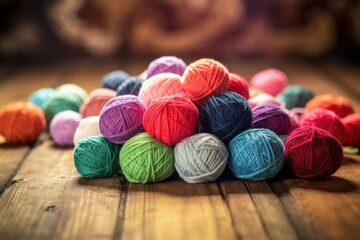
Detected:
[143,96,199,145]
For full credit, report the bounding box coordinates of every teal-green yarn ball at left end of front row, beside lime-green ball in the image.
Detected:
[74,136,120,178]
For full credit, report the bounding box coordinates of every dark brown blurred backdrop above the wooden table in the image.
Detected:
[0,0,360,62]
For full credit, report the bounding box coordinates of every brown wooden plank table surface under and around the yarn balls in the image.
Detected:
[0,59,360,240]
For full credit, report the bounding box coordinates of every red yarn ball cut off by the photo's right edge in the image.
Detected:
[342,113,360,147]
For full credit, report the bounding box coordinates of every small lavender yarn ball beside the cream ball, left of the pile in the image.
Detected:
[50,110,81,146]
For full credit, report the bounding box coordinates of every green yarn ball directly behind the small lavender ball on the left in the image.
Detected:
[43,92,83,125]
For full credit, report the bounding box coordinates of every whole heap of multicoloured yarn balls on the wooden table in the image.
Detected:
[0,56,360,183]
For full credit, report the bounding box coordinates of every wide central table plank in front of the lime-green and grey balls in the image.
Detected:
[120,180,236,240]
